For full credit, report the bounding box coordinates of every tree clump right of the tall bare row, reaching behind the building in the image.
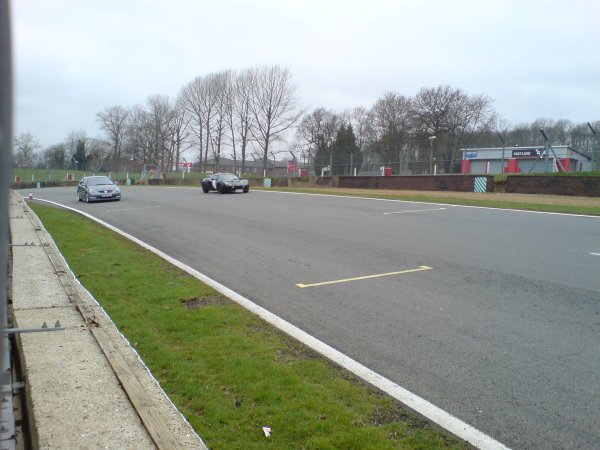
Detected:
[294,85,600,175]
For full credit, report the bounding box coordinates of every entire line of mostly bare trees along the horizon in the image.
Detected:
[14,66,600,175]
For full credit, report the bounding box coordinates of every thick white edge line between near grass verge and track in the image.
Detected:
[29,194,508,450]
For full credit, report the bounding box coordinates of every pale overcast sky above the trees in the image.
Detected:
[11,0,600,147]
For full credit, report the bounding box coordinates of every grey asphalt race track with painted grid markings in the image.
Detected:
[21,186,600,448]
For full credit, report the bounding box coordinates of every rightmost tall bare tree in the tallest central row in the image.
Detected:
[250,66,302,173]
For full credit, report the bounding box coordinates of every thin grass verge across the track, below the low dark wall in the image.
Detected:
[254,187,600,216]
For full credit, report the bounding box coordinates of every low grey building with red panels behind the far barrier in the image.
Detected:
[461,145,593,175]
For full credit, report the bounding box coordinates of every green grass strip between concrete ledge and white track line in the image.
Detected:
[30,203,468,449]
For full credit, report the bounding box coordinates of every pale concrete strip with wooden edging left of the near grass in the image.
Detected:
[9,192,207,449]
